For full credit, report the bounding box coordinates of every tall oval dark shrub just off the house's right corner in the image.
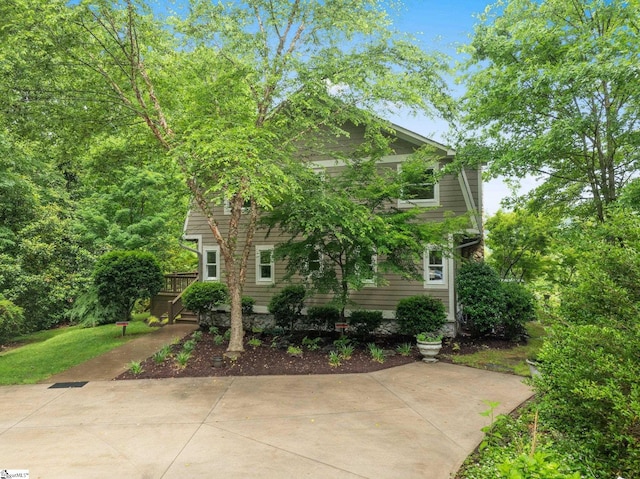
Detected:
[456,261,504,336]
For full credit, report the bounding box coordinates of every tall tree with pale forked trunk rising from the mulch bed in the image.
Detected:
[21,0,450,355]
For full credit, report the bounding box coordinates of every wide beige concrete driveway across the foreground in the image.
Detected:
[0,326,531,479]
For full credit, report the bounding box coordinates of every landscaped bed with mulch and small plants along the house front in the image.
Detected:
[116,331,528,379]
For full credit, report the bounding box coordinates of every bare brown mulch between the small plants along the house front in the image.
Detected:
[115,331,515,380]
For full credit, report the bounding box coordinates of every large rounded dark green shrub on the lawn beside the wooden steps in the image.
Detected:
[93,251,164,320]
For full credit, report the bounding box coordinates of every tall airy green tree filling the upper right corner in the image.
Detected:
[459,0,640,221]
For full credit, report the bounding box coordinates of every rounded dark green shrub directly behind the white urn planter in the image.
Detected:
[396,295,447,336]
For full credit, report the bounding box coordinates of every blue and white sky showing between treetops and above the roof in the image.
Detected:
[156,0,531,216]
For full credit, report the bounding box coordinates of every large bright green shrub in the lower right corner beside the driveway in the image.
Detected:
[534,324,640,477]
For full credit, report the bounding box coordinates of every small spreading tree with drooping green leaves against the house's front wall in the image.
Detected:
[262,155,468,318]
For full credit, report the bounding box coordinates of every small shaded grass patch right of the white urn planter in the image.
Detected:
[444,321,545,376]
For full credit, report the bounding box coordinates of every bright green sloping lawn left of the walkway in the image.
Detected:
[0,321,154,385]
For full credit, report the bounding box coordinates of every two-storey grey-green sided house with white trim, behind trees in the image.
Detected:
[170,125,482,335]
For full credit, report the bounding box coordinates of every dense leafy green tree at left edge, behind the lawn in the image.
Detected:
[0,130,93,331]
